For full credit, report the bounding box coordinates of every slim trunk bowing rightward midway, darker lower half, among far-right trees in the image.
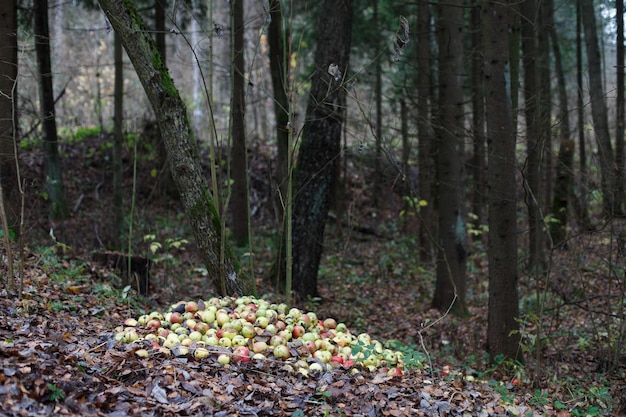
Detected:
[546,0,574,246]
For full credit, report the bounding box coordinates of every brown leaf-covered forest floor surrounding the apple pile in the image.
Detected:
[0,133,626,417]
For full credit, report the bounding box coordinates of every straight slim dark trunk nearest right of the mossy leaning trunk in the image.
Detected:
[230,1,249,246]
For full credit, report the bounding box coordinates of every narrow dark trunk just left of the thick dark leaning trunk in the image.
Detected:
[268,0,291,224]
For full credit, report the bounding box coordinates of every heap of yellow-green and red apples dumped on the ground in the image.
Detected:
[115,296,404,376]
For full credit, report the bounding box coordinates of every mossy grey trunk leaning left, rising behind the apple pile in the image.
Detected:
[99,0,254,295]
